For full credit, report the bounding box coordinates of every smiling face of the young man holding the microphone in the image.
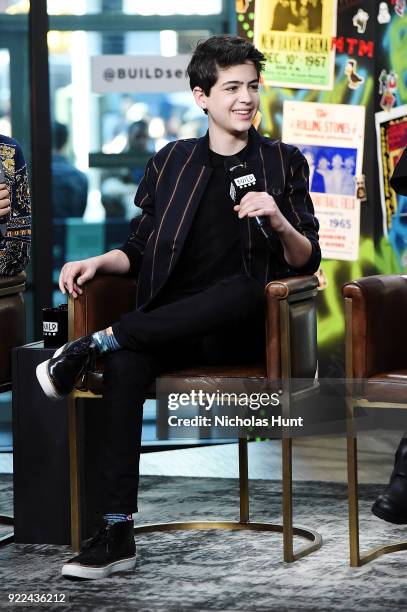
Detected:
[193,61,259,145]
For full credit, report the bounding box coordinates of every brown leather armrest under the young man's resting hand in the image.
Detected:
[68,274,137,340]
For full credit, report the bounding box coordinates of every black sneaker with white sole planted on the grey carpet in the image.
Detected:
[62,521,136,580]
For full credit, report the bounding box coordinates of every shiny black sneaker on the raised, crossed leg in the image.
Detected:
[36,335,99,400]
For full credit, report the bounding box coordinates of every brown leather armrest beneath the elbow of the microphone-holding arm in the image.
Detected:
[266,275,319,379]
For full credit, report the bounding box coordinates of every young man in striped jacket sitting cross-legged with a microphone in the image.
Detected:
[37,35,320,578]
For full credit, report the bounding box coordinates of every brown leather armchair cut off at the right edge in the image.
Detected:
[342,275,407,567]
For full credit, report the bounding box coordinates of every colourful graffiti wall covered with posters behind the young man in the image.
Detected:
[236,0,407,377]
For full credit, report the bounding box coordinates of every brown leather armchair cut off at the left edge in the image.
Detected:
[0,272,26,544]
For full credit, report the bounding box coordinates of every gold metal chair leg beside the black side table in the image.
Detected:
[68,395,81,552]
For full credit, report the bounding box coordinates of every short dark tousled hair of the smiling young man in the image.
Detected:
[187,34,265,96]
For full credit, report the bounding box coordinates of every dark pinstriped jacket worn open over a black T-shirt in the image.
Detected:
[121,128,321,308]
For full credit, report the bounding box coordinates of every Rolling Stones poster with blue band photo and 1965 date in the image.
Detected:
[283,101,365,261]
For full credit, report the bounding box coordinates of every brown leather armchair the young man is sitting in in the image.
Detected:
[68,275,322,561]
